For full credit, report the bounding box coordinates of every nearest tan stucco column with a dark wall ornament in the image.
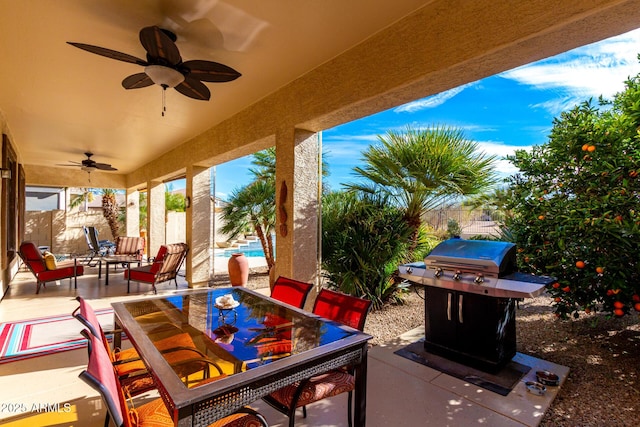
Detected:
[273,128,320,283]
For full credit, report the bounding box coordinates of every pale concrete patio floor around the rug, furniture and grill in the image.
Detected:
[0,262,568,427]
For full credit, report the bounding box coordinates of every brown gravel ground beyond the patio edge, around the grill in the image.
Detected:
[213,269,640,427]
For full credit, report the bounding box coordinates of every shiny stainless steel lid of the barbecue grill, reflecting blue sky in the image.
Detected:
[424,239,517,277]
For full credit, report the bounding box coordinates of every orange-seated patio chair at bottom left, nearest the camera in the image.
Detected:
[79,329,268,427]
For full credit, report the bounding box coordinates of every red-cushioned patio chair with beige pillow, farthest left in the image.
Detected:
[18,241,84,294]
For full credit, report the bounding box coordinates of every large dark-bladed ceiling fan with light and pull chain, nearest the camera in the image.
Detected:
[67,26,241,101]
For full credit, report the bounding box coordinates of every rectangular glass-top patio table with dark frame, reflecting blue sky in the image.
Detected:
[112,287,371,426]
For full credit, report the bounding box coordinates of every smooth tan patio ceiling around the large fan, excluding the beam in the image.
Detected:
[0,0,430,177]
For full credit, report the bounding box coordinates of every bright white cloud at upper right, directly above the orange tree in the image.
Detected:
[500,30,640,103]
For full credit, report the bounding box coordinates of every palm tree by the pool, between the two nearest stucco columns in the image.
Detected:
[221,179,276,271]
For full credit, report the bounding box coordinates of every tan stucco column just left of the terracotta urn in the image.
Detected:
[186,166,213,288]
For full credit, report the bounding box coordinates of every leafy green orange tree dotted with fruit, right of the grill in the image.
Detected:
[505,75,640,318]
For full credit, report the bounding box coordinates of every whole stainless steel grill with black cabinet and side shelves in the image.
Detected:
[398,239,555,371]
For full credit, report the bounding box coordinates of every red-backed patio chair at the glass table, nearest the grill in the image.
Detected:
[262,289,371,427]
